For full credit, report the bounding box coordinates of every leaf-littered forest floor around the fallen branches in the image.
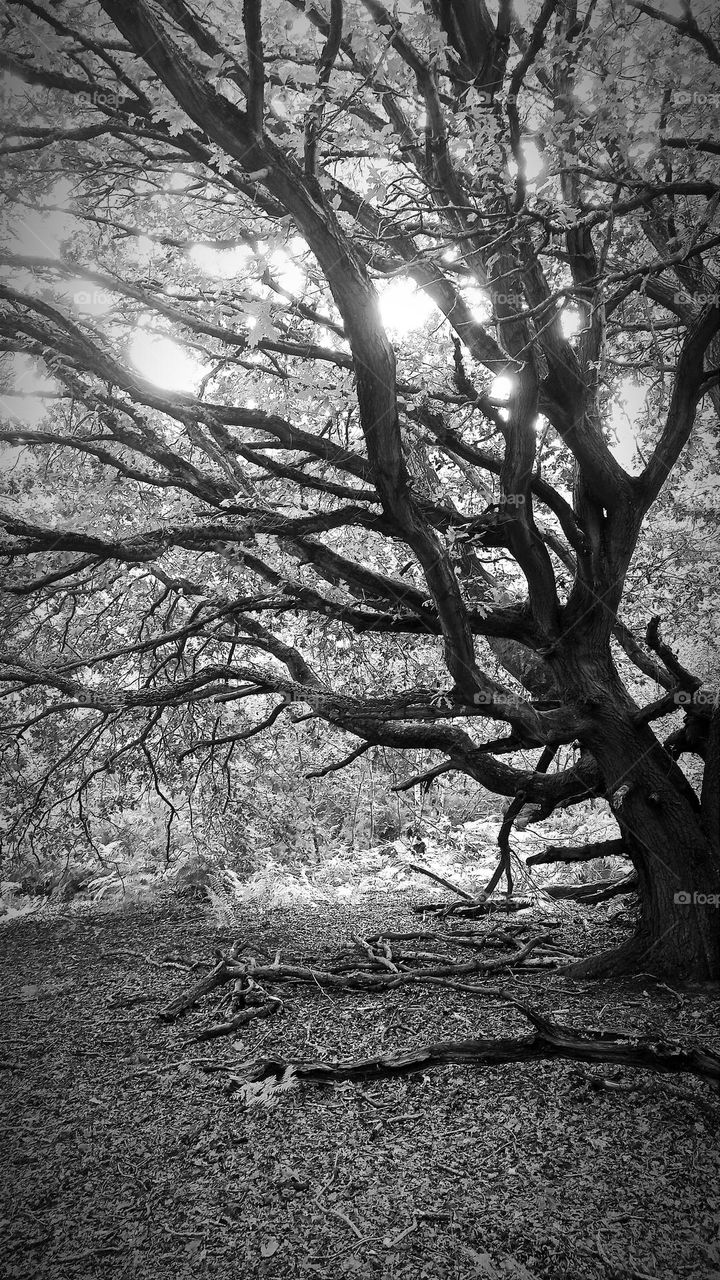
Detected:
[0,891,720,1280]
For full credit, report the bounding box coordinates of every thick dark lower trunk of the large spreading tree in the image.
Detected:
[556,650,720,982]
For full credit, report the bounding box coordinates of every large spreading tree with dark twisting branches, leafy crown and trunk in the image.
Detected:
[0,0,720,978]
